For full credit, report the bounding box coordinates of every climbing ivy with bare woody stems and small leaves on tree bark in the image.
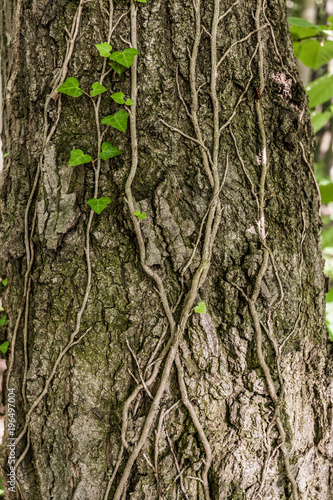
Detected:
[0,0,313,500]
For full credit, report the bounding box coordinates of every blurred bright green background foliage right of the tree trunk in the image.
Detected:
[288,16,333,342]
